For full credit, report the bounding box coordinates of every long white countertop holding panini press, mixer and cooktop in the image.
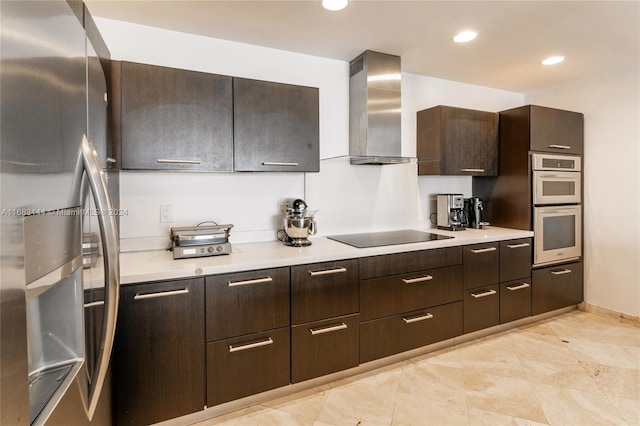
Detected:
[120,226,533,284]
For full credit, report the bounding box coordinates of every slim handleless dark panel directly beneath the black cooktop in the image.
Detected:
[360,247,462,280]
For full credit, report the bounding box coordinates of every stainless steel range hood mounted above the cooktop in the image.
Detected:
[349,50,410,164]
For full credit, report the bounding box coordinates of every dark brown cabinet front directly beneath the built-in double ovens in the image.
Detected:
[531,262,583,315]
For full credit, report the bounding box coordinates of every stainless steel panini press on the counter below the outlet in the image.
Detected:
[171,225,233,259]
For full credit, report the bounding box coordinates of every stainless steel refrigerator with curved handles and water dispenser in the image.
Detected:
[0,0,119,425]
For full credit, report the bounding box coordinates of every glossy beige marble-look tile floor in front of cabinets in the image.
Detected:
[192,311,640,426]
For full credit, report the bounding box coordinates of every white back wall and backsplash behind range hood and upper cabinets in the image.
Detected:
[96,19,524,250]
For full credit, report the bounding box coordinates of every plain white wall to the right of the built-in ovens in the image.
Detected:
[526,69,640,317]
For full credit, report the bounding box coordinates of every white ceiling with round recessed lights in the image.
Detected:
[85,0,640,93]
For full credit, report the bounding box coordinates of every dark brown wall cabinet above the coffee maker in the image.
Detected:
[417,105,498,176]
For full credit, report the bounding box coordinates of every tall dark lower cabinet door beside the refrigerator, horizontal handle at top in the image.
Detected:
[114,278,205,425]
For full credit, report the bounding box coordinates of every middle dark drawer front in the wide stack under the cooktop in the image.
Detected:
[360,266,463,321]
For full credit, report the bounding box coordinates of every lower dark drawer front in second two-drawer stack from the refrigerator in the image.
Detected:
[291,314,359,383]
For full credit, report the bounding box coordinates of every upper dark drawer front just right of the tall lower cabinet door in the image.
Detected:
[206,268,289,342]
